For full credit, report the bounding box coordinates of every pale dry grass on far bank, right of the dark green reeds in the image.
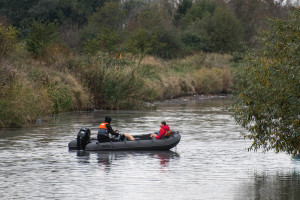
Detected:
[139,52,232,100]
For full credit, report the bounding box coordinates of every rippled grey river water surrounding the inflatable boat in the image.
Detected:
[0,97,300,200]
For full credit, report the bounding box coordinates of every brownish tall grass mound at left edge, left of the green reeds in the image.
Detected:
[0,52,90,127]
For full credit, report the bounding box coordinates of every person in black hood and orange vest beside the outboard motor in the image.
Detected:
[97,117,134,142]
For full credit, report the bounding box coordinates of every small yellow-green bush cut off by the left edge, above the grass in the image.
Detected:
[0,23,19,57]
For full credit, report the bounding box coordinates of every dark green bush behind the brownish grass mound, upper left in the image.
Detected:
[26,20,59,58]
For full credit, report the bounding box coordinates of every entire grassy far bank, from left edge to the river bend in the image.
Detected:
[0,51,232,127]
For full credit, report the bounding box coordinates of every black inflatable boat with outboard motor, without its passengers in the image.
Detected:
[69,128,181,151]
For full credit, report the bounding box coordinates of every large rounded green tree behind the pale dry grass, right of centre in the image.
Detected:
[181,0,243,53]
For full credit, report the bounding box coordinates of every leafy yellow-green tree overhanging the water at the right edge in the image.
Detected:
[231,9,300,155]
